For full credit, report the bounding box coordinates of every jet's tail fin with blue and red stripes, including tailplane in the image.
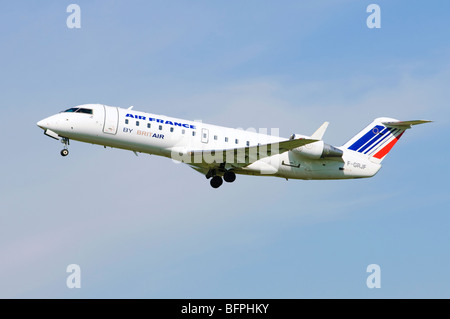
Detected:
[343,117,431,163]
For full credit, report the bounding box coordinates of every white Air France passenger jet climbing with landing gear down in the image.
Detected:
[37,104,431,188]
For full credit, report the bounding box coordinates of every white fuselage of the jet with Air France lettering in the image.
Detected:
[38,104,381,179]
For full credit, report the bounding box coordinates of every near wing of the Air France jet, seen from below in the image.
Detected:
[182,138,318,167]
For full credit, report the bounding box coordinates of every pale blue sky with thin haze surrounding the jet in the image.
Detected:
[0,0,450,298]
